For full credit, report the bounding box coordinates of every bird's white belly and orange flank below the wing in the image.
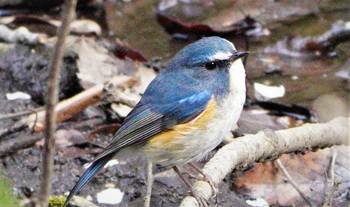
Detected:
[144,95,239,166]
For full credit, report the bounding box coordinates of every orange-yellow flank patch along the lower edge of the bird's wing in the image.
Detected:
[148,98,216,146]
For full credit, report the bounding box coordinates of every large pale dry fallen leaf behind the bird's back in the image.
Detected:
[60,36,155,90]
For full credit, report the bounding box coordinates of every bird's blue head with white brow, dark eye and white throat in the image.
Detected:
[167,37,249,96]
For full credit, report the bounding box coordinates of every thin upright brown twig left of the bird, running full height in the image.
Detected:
[39,0,77,207]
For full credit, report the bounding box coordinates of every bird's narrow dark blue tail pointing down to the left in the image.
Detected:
[63,153,116,207]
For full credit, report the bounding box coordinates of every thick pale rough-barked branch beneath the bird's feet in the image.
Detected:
[180,117,350,207]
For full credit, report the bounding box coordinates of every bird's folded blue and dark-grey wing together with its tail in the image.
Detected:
[64,90,211,206]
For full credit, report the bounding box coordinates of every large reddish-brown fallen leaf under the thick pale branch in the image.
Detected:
[233,146,350,206]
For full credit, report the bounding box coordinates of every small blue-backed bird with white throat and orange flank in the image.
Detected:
[64,37,248,206]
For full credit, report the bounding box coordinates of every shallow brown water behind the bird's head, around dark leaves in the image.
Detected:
[107,0,350,113]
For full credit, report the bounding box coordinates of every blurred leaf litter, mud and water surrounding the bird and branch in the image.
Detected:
[0,0,350,206]
